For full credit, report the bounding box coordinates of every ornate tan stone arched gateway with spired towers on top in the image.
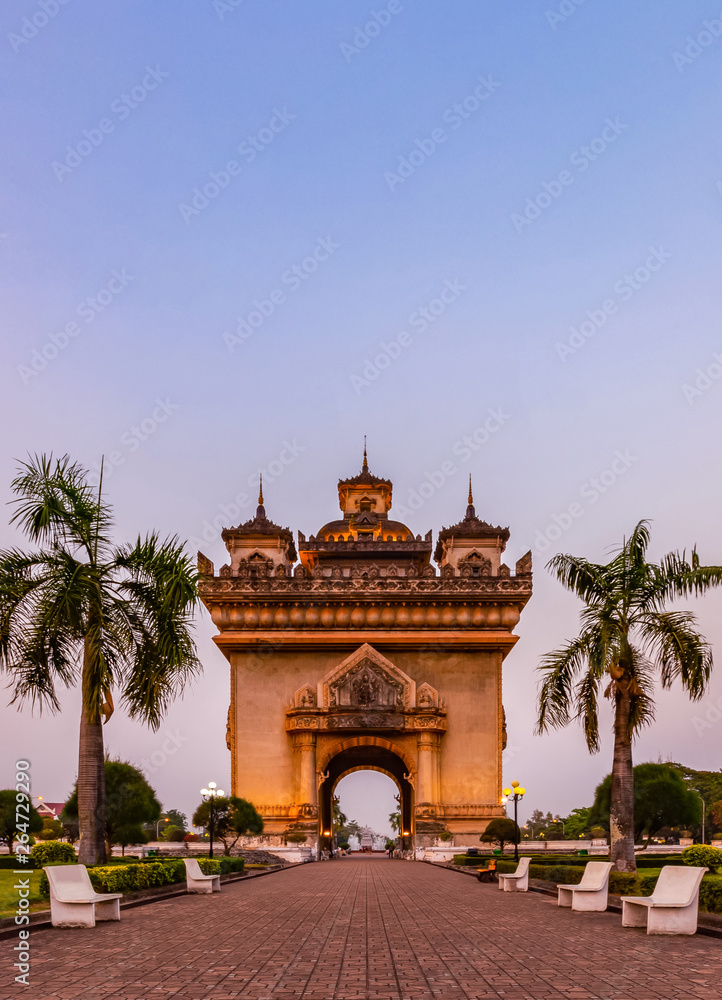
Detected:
[198,454,532,847]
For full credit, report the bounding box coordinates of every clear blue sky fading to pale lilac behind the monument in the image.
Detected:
[0,0,722,832]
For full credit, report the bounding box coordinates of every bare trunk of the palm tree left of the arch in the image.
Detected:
[78,642,107,865]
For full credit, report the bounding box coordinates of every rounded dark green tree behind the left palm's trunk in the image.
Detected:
[62,760,160,855]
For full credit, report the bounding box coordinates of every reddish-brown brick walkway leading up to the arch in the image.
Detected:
[0,858,722,1000]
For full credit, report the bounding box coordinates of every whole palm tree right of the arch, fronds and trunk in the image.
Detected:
[537,521,722,871]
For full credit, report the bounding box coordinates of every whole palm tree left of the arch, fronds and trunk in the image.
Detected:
[0,455,200,864]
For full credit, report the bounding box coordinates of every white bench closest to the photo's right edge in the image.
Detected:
[622,865,707,934]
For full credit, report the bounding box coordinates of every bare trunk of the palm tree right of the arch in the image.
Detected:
[609,685,637,872]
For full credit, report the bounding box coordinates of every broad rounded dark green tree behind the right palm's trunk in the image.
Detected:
[591,764,702,841]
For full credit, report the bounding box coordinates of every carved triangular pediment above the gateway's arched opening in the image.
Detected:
[319,643,416,711]
